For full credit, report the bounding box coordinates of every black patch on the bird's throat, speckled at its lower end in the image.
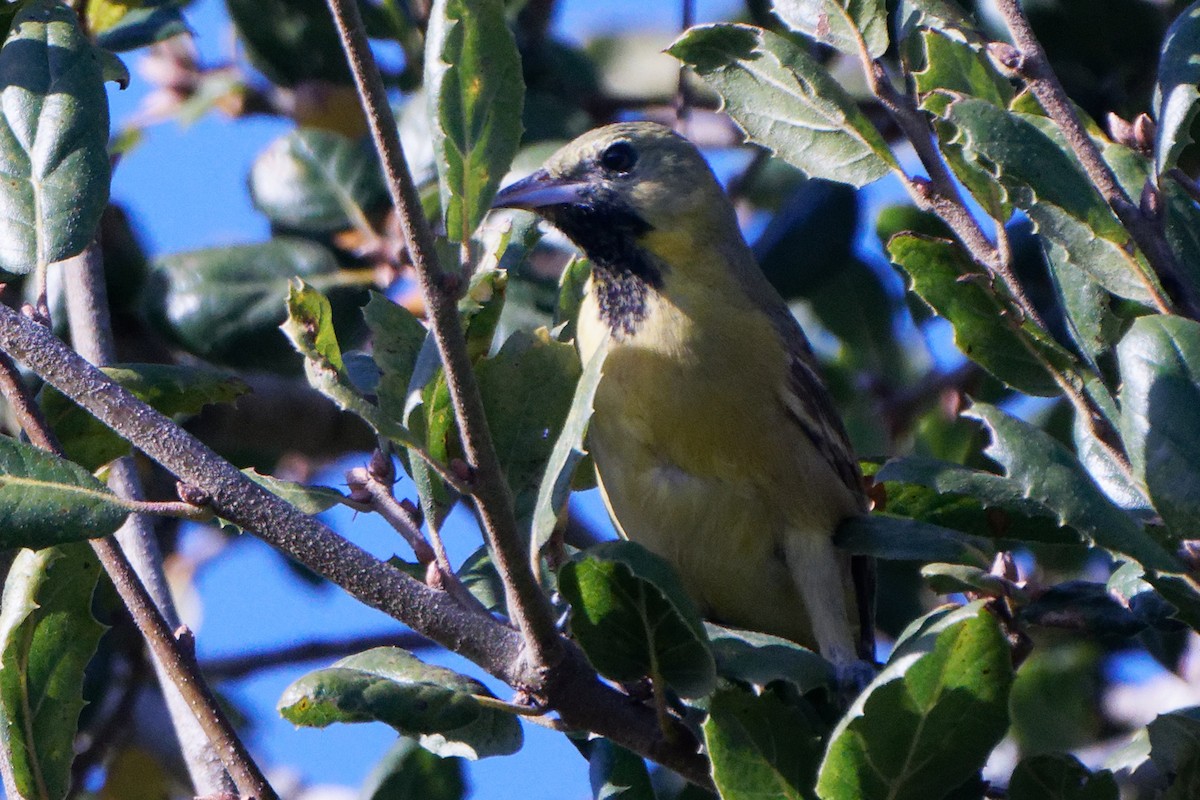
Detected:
[544,190,666,338]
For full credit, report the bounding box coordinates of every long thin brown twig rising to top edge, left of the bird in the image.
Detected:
[328,0,563,668]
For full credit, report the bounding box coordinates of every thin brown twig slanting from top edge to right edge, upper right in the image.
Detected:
[996,0,1198,318]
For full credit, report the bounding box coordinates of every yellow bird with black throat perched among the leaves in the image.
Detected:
[496,122,872,672]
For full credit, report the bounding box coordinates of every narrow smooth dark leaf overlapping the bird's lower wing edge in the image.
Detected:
[833,513,995,566]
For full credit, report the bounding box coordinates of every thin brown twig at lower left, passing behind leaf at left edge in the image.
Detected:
[0,347,276,800]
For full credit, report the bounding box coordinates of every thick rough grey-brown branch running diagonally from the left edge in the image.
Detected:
[0,306,712,787]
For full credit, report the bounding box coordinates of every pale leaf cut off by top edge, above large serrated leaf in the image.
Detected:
[772,0,888,59]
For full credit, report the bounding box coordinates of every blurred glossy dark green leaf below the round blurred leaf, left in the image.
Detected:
[146,237,359,369]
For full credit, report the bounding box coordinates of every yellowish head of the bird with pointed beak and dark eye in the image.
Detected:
[493,122,737,282]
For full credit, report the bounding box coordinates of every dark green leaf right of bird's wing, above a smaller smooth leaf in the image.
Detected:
[875,456,1081,543]
